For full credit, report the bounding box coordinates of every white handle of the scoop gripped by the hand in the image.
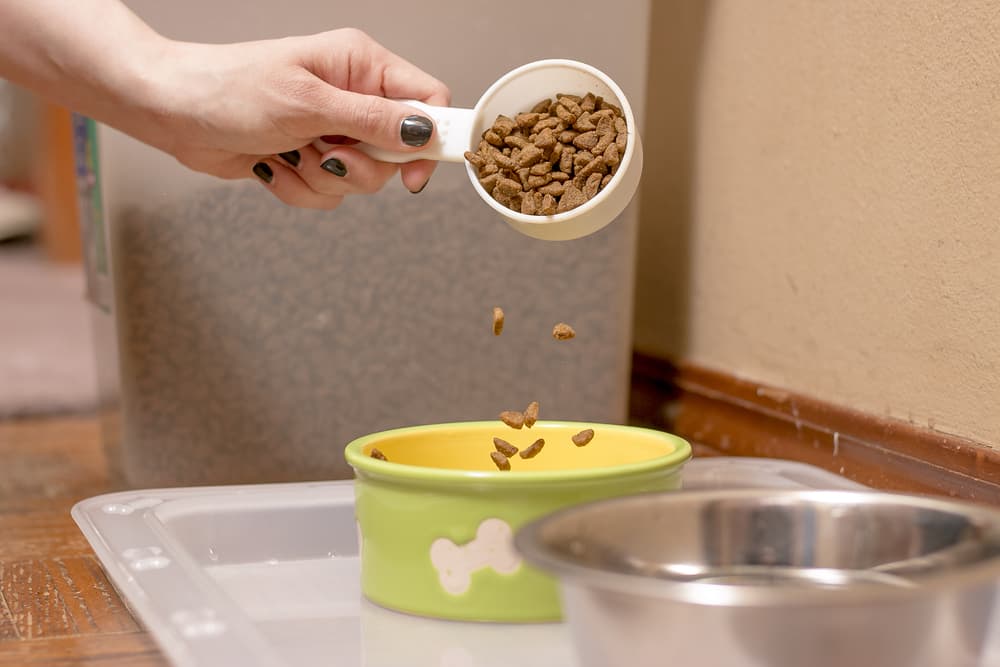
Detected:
[313,100,475,164]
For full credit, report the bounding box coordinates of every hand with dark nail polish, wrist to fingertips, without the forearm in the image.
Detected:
[144,29,451,209]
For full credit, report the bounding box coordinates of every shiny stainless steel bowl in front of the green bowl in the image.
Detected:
[516,489,1000,667]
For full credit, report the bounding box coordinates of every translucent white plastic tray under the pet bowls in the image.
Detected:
[73,458,864,667]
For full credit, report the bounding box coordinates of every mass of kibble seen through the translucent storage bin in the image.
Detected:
[101,168,635,486]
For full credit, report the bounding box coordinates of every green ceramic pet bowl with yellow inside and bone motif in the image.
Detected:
[346,421,691,623]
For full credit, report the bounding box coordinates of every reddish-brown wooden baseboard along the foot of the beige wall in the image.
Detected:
[631,353,1000,504]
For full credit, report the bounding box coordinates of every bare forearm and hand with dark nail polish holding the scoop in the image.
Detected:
[0,0,450,208]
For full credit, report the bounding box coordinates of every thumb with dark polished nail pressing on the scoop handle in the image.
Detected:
[316,86,434,151]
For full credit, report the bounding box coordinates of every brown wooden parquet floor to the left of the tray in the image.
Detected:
[0,417,169,667]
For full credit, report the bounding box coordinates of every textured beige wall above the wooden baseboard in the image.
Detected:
[635,0,1000,446]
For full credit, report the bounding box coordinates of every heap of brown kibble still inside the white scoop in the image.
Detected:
[465,93,628,215]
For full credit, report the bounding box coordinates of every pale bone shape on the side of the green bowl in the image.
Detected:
[431,519,521,595]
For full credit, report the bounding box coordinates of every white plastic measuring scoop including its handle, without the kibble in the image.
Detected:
[315,60,642,241]
